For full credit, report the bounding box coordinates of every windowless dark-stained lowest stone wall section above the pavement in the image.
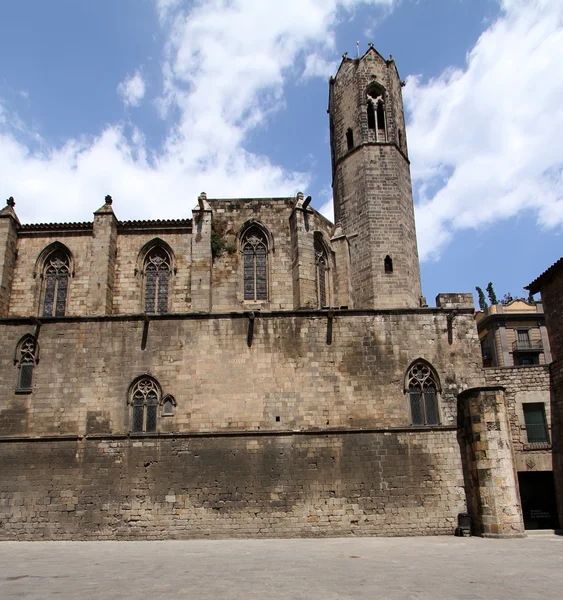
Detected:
[0,430,466,540]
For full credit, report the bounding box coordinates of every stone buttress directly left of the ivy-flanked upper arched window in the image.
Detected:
[191,192,213,312]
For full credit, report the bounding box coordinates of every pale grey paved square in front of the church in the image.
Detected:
[0,535,563,600]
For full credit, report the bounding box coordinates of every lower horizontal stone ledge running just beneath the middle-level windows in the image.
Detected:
[0,425,457,443]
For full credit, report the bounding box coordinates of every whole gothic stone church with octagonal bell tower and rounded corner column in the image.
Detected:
[0,47,523,539]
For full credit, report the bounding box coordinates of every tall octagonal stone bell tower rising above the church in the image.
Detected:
[329,45,421,309]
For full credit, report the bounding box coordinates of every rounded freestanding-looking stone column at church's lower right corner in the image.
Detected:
[460,387,525,538]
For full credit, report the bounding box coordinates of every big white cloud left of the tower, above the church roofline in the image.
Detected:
[0,0,396,222]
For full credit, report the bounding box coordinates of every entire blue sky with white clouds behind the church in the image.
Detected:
[0,0,563,304]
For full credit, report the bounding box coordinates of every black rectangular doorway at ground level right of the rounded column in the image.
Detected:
[518,471,559,529]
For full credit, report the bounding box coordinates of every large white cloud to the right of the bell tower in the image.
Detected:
[404,0,563,259]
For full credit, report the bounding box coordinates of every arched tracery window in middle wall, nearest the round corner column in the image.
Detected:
[406,361,440,425]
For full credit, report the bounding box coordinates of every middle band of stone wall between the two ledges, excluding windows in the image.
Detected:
[0,309,482,435]
